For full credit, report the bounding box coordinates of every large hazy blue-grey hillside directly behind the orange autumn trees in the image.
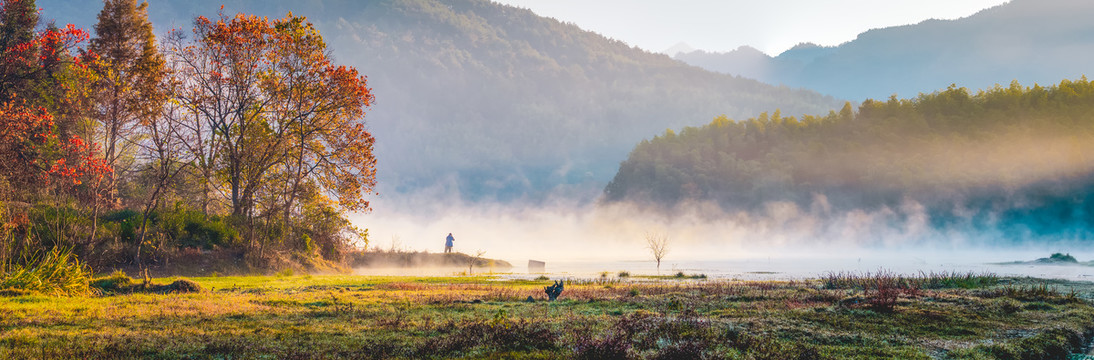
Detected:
[40,0,841,199]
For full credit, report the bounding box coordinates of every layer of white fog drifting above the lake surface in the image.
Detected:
[356,193,1090,265]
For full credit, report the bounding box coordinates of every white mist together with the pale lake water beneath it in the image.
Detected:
[354,193,1094,280]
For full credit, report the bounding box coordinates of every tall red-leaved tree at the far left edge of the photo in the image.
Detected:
[0,0,95,195]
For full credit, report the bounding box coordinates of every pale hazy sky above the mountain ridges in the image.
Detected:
[494,0,1008,56]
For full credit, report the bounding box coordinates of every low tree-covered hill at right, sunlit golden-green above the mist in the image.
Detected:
[605,78,1094,236]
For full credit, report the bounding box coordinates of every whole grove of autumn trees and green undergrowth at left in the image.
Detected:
[0,0,375,289]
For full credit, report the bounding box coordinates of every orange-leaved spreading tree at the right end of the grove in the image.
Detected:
[168,13,375,252]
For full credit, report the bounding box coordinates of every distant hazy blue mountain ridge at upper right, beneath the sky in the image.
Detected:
[676,0,1094,101]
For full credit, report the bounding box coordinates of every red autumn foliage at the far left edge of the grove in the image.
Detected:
[0,1,109,199]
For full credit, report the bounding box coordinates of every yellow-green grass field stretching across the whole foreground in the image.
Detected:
[0,270,1094,359]
